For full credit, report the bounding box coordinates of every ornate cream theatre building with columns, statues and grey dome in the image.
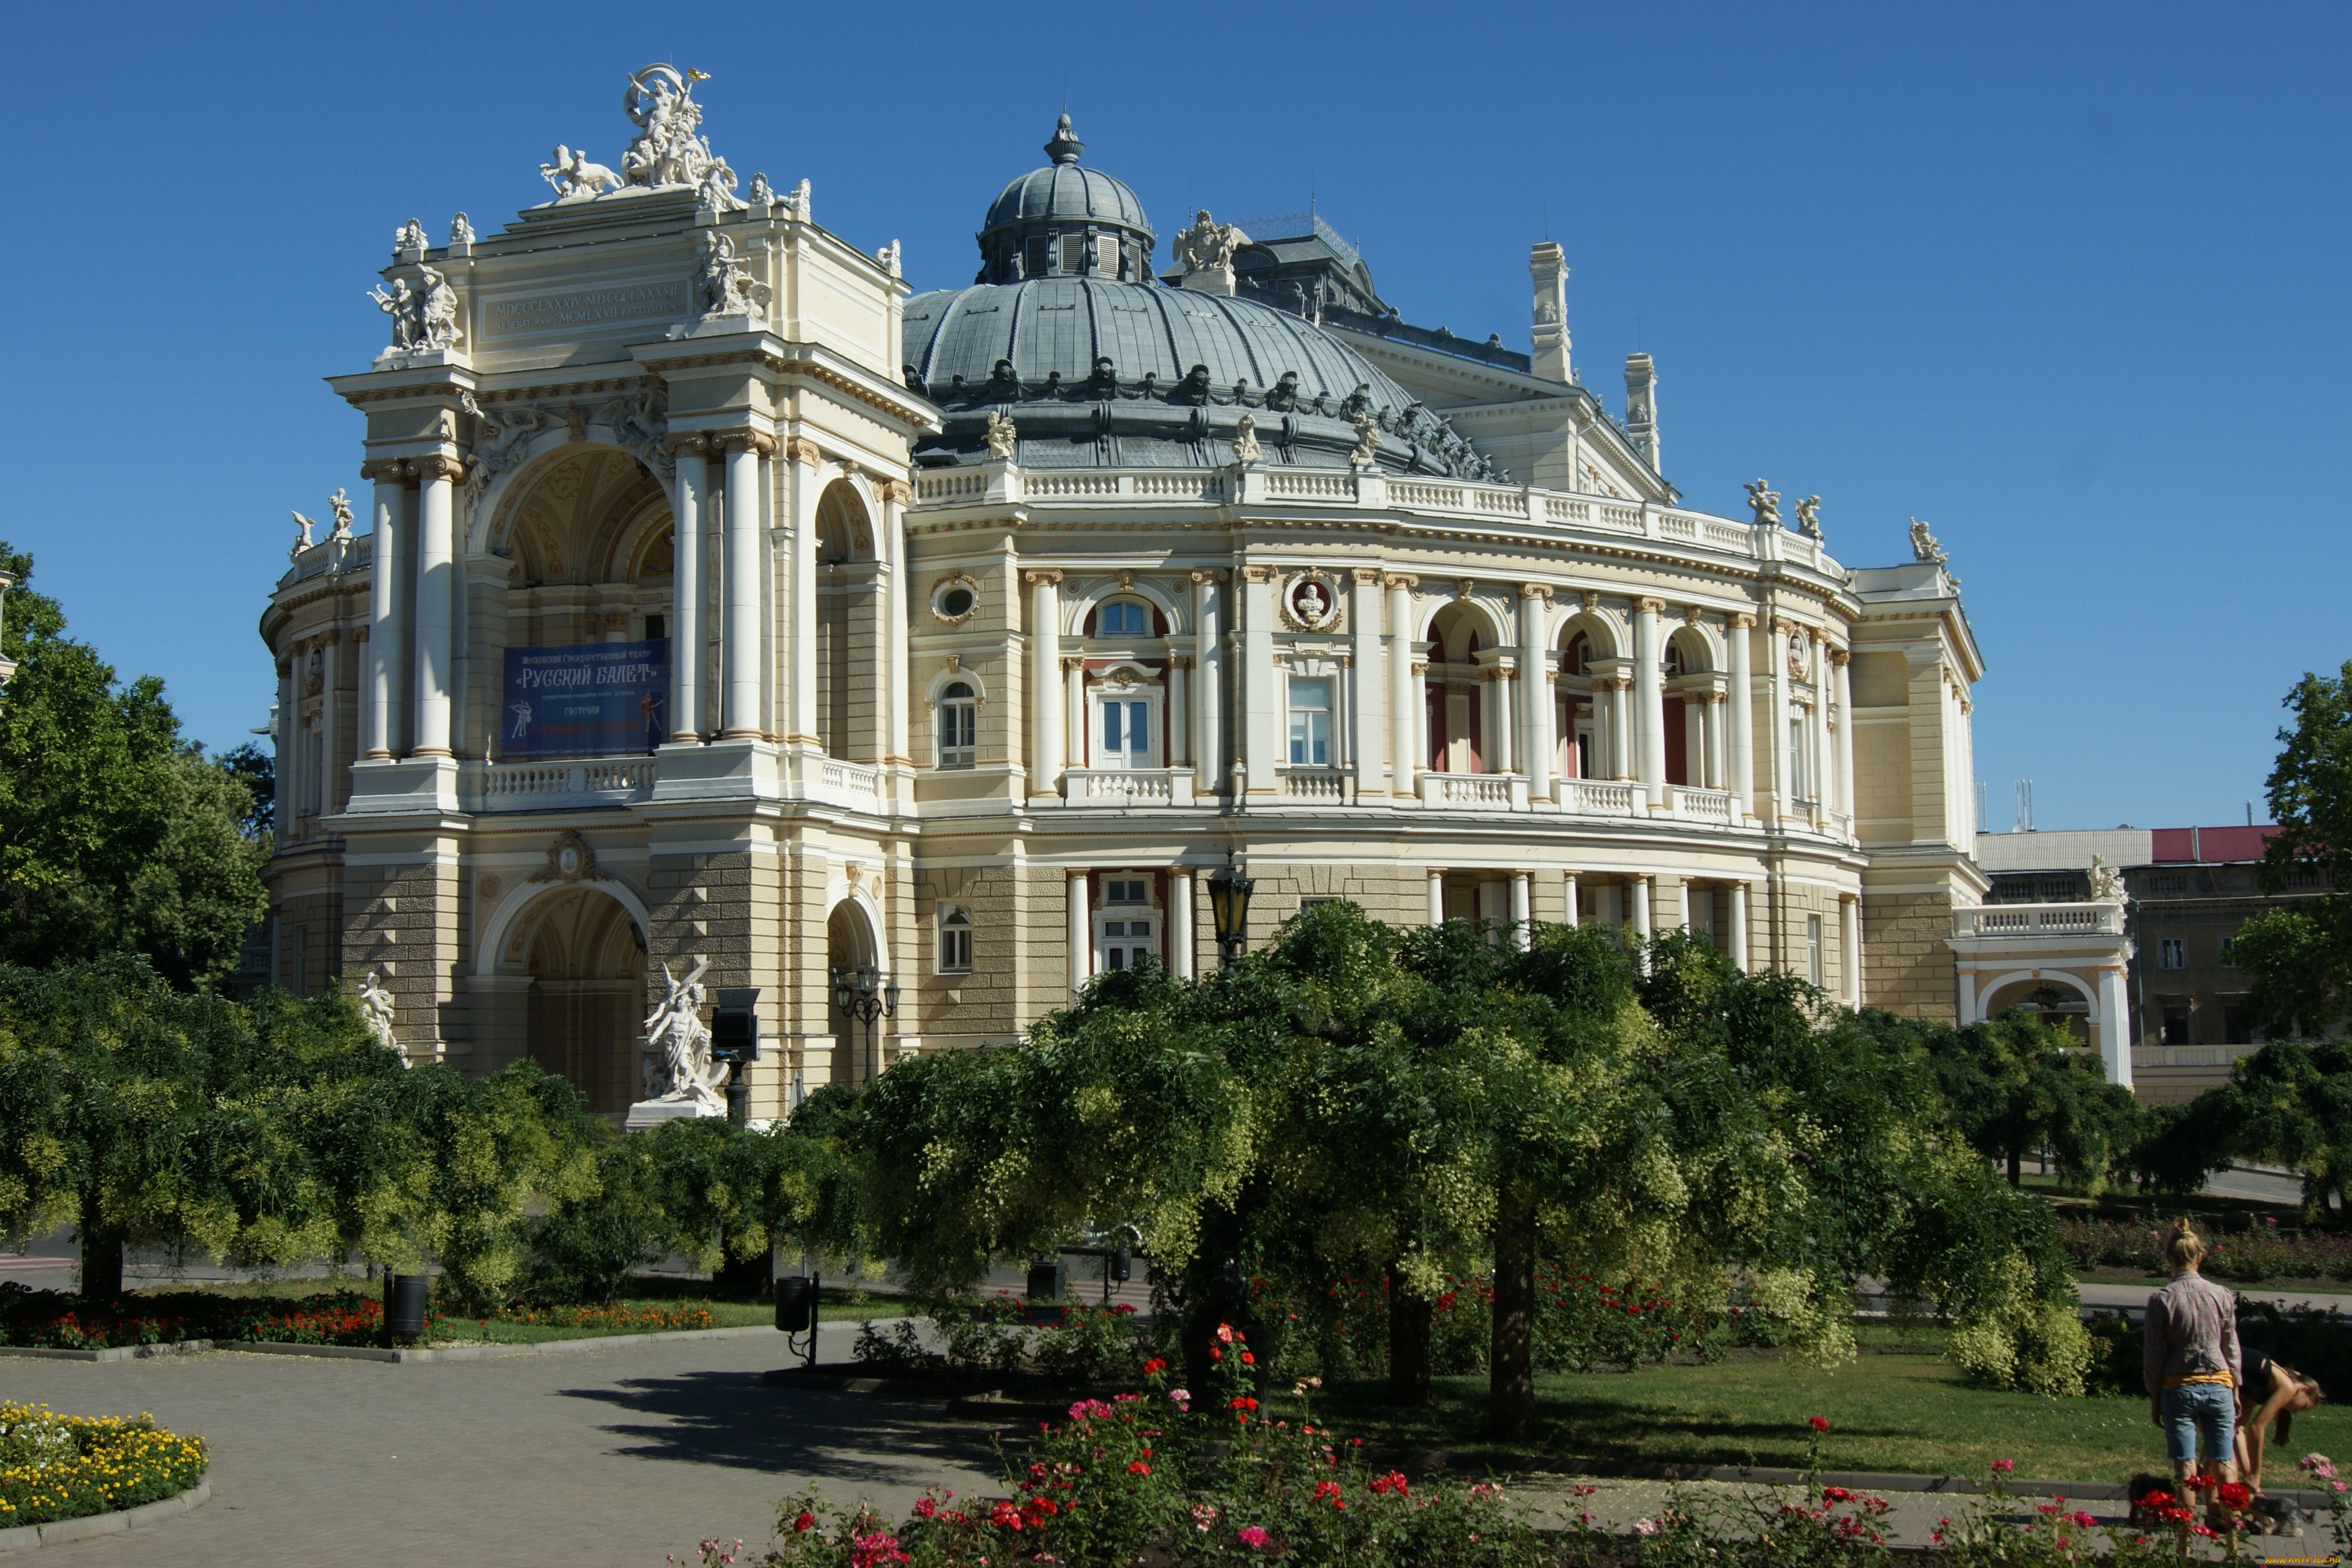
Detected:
[261,66,2004,1117]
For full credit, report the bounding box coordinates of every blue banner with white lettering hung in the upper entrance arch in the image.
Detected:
[499,637,670,762]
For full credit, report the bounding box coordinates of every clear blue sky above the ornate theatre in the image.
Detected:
[0,5,2352,828]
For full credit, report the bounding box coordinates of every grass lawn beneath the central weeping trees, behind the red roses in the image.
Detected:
[1268,1350,2352,1486]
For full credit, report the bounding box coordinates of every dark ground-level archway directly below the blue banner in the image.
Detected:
[506,884,645,1112]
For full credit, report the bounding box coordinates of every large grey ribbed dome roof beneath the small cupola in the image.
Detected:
[905,278,1489,477]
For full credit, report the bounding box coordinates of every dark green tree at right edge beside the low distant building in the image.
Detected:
[2237,660,2352,1034]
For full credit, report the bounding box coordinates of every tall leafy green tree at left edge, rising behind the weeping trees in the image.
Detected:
[0,543,268,990]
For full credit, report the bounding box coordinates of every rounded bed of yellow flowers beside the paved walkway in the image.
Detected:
[0,1399,207,1530]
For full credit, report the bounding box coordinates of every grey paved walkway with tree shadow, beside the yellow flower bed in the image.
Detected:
[0,1324,995,1568]
